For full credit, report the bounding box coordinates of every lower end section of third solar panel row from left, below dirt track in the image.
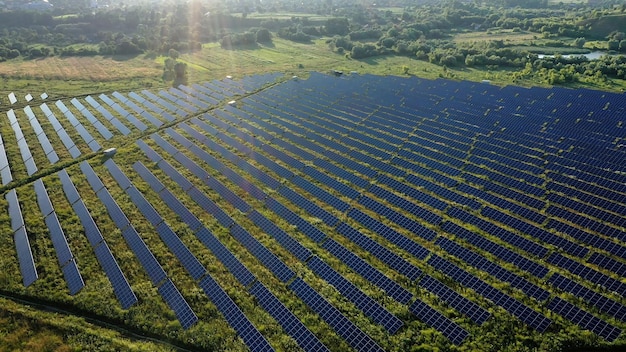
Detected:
[94,241,137,309]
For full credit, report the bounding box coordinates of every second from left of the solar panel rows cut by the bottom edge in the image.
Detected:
[250,282,328,352]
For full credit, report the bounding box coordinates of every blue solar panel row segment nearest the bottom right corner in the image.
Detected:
[548,297,622,342]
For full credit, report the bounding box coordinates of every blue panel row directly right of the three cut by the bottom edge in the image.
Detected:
[308,256,404,334]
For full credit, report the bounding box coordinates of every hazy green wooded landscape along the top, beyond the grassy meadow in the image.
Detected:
[0,0,626,88]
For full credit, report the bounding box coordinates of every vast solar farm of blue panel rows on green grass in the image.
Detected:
[0,73,626,351]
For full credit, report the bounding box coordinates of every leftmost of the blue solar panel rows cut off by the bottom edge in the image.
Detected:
[200,275,274,352]
